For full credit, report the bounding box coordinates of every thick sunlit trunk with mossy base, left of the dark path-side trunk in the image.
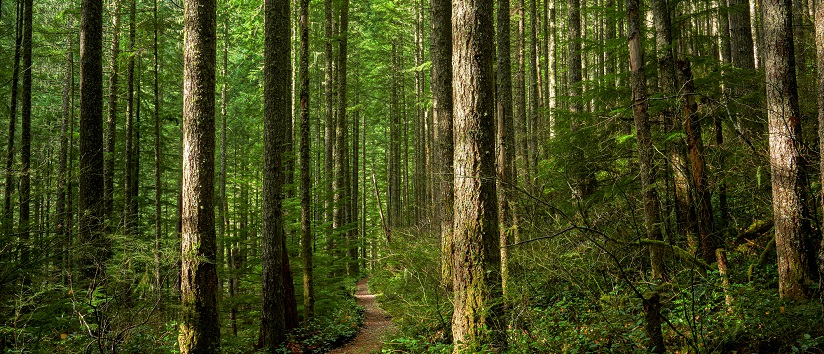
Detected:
[178,0,220,353]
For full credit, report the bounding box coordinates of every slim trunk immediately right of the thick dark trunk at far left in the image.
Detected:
[104,0,122,233]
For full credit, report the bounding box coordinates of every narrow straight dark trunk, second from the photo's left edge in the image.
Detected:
[17,0,32,264]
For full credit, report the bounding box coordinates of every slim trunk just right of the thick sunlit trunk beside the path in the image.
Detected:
[495,0,515,295]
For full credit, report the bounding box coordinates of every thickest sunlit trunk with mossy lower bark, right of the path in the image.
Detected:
[452,0,505,352]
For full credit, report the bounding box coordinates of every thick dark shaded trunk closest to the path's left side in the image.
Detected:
[258,0,291,350]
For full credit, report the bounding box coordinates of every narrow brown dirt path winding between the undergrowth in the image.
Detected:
[329,278,395,354]
